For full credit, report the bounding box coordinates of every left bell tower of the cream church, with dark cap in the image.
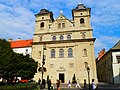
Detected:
[35,9,54,31]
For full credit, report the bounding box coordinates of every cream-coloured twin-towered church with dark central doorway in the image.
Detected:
[32,4,97,83]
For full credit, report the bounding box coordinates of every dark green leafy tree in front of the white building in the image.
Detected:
[0,39,37,79]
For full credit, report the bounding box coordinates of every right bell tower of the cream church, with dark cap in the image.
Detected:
[72,3,91,27]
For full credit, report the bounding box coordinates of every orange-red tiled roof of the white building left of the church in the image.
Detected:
[10,39,33,48]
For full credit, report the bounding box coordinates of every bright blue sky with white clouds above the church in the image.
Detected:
[0,0,120,56]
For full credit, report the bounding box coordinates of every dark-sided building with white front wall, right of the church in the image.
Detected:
[96,40,120,83]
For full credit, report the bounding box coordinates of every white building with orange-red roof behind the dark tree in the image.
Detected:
[9,38,33,57]
